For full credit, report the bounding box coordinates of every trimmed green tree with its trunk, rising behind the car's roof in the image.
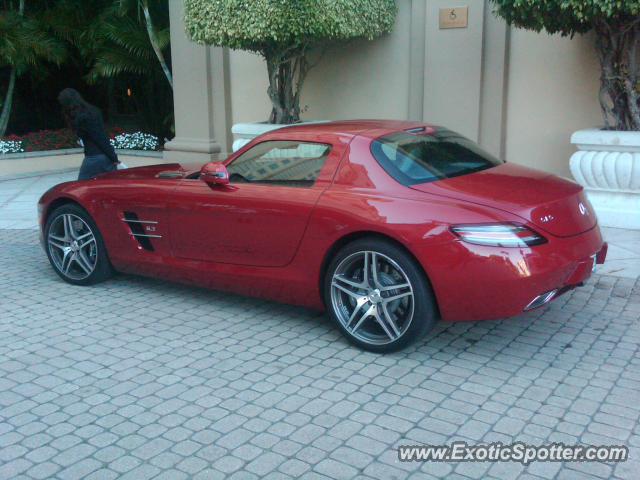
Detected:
[185,0,396,123]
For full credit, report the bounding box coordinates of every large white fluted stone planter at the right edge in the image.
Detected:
[570,129,640,229]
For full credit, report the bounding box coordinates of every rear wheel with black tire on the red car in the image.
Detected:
[323,237,438,353]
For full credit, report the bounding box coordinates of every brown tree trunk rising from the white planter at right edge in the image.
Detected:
[595,20,640,130]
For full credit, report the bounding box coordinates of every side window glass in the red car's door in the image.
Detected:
[227,141,331,187]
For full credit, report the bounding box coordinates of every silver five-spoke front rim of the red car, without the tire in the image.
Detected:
[47,213,98,280]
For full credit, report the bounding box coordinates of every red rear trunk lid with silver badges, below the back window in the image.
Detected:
[411,163,597,237]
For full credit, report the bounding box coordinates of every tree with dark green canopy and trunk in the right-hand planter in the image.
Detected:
[492,0,640,130]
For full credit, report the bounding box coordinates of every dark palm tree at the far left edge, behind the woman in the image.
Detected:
[0,0,66,137]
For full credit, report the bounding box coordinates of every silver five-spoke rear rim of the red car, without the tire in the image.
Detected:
[331,251,414,345]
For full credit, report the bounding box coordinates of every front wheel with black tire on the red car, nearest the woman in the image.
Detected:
[44,203,113,285]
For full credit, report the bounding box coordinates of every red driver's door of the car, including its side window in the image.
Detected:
[171,138,344,267]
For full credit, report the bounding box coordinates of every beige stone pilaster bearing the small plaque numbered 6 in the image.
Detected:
[410,0,509,158]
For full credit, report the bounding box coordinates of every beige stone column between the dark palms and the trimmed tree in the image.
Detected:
[164,0,231,163]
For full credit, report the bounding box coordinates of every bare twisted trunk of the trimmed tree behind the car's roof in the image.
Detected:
[263,47,309,124]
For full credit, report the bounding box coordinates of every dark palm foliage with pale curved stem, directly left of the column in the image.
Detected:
[45,0,173,139]
